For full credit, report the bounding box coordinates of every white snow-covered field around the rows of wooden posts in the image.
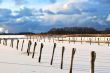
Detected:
[0,35,110,73]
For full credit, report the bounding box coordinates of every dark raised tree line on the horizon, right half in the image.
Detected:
[47,27,110,34]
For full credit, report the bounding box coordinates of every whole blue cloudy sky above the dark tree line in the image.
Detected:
[0,0,110,33]
